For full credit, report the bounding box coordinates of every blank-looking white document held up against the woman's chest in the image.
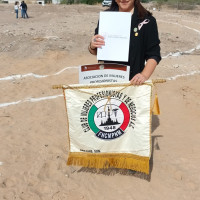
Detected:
[97,12,131,62]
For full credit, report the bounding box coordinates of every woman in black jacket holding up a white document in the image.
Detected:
[88,0,161,85]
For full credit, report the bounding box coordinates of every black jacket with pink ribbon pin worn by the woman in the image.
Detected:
[95,8,161,79]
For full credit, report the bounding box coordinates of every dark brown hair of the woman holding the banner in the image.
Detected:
[109,0,152,19]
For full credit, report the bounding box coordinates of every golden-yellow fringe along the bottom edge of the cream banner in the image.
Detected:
[67,152,149,174]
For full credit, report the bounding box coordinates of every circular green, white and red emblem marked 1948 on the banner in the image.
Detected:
[88,98,130,140]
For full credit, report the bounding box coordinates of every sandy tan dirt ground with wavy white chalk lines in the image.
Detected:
[0,4,200,200]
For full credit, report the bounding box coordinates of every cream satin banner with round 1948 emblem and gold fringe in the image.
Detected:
[63,82,152,174]
